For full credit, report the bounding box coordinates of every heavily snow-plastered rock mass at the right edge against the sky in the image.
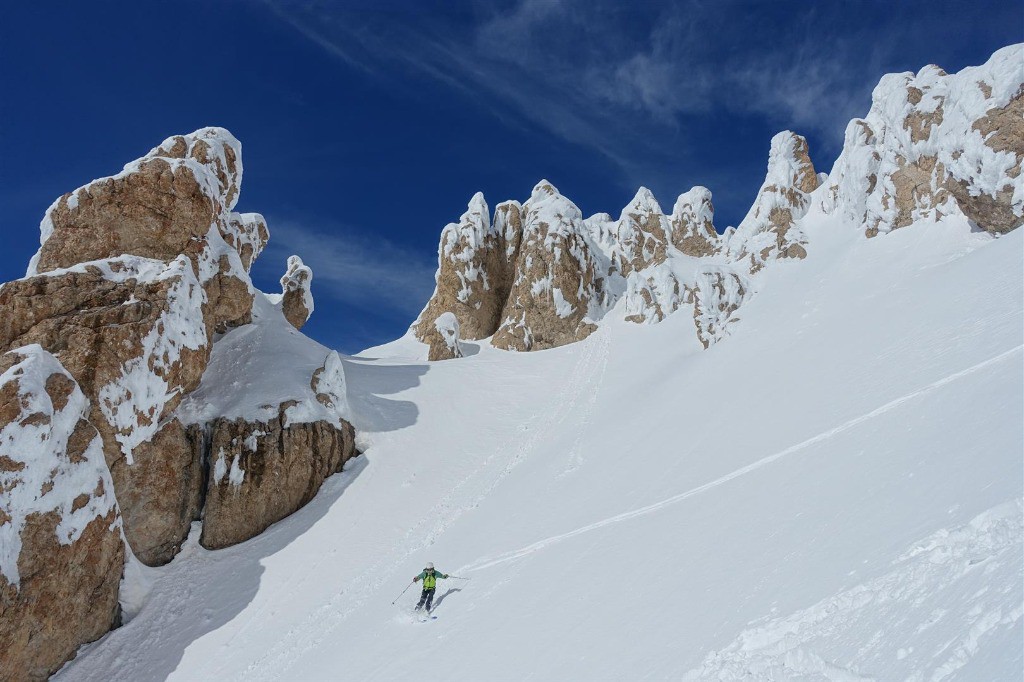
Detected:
[822,45,1024,237]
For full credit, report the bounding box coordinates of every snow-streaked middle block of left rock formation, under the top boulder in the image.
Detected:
[0,255,213,563]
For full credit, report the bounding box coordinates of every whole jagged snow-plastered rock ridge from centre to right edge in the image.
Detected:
[403,45,1024,352]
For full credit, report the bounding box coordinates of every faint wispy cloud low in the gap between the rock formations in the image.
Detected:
[254,220,437,321]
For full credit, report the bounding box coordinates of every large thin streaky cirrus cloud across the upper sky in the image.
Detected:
[270,0,879,165]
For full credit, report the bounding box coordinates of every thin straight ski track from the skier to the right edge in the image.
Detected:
[457,344,1024,572]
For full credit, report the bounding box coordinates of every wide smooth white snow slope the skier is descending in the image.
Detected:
[57,212,1024,681]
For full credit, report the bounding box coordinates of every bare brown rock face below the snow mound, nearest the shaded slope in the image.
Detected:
[200,404,355,549]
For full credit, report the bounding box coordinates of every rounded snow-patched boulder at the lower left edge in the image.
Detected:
[0,345,124,680]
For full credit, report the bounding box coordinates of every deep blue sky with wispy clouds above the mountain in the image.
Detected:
[0,0,1024,352]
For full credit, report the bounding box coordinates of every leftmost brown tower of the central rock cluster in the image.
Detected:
[413,193,522,345]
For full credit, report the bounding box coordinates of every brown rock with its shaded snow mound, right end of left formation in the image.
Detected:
[175,294,355,549]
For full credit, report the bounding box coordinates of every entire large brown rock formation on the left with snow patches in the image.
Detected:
[0,128,354,679]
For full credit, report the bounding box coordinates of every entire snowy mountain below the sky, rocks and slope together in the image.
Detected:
[0,46,1024,681]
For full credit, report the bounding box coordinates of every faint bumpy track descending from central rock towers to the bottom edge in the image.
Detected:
[232,339,608,680]
